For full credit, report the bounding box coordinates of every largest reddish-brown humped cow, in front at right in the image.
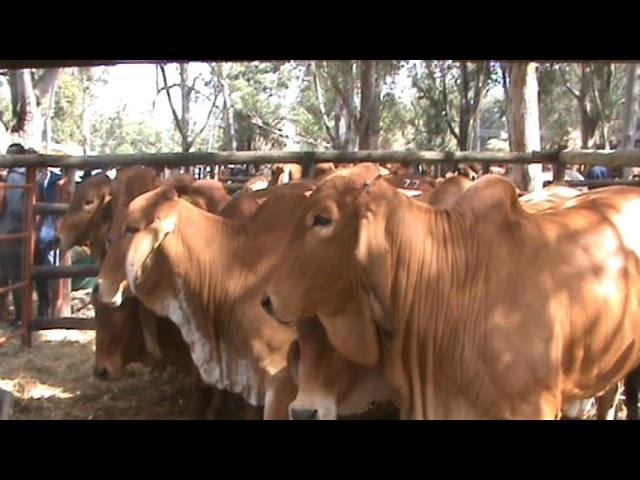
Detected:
[261,175,640,419]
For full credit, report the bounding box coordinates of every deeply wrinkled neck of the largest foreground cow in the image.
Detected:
[386,193,484,418]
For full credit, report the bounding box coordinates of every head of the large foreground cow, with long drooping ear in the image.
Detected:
[262,176,398,366]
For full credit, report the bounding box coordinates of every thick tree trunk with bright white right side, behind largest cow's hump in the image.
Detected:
[508,62,542,191]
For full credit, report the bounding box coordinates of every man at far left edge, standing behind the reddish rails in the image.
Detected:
[0,143,27,328]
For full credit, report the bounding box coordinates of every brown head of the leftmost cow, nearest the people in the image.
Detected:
[58,173,112,252]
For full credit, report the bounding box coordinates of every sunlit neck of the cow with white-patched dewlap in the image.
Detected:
[164,204,286,405]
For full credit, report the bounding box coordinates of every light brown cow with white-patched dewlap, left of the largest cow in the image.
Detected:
[98,187,320,419]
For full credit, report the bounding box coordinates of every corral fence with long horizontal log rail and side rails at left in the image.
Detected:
[0,150,640,346]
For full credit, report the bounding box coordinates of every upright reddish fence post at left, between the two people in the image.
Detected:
[22,167,36,347]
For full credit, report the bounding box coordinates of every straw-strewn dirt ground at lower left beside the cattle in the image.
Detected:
[0,292,195,420]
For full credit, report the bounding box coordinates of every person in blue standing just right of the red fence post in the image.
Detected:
[33,149,62,317]
